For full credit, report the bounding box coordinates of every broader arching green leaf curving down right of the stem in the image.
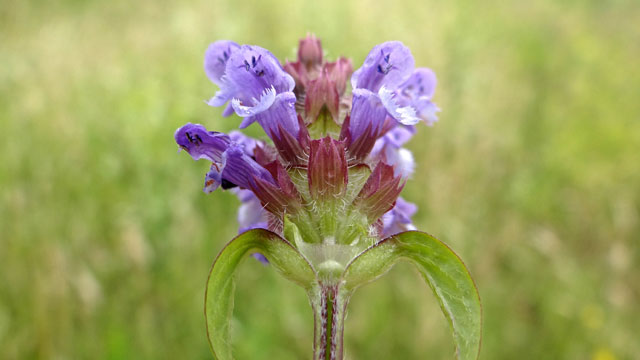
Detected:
[344,231,482,360]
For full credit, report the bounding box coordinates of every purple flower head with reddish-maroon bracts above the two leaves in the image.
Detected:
[175,35,439,247]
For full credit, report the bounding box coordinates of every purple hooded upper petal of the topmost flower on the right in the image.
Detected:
[351,41,414,92]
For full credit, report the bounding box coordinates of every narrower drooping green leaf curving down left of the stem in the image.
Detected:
[204,229,316,360]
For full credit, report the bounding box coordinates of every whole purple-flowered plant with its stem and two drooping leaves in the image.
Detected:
[175,36,481,360]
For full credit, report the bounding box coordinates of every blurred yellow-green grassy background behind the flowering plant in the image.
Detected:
[0,0,640,360]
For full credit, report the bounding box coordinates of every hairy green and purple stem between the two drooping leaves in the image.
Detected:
[309,284,349,360]
